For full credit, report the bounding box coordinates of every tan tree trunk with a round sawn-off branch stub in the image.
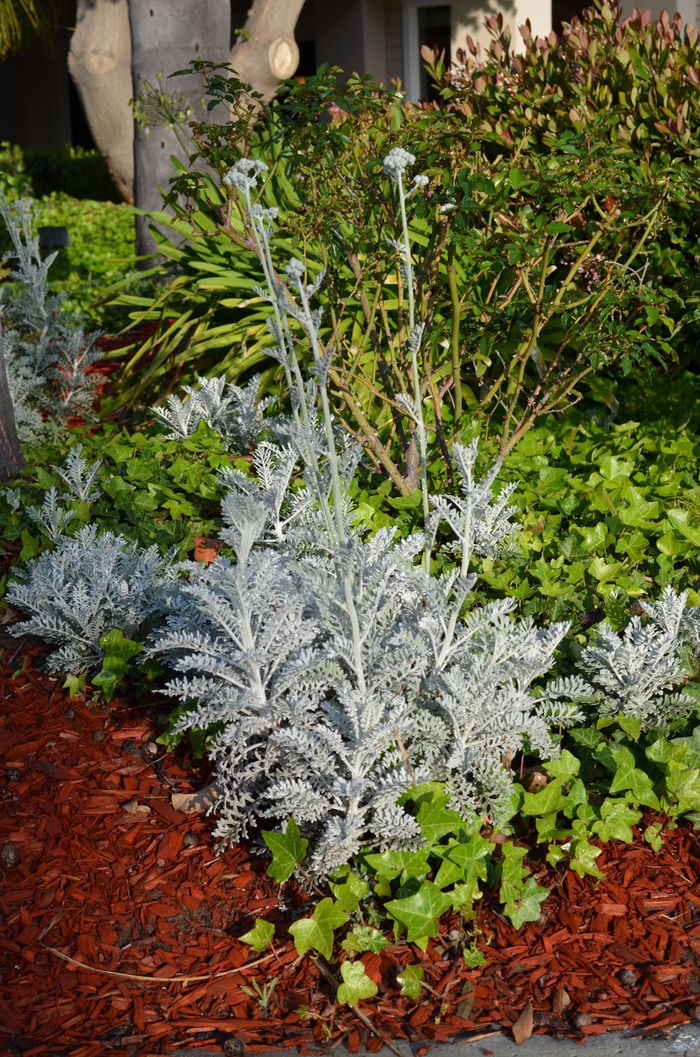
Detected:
[231,0,306,100]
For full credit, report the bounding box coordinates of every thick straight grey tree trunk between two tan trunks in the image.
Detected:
[129,0,231,267]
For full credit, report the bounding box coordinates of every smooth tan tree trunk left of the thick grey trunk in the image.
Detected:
[68,0,133,202]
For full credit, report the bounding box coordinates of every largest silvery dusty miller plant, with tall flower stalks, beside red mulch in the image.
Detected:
[154,150,587,876]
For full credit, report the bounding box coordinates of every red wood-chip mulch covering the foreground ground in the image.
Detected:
[0,647,700,1057]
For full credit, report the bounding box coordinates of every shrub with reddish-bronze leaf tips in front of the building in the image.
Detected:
[424,0,700,162]
